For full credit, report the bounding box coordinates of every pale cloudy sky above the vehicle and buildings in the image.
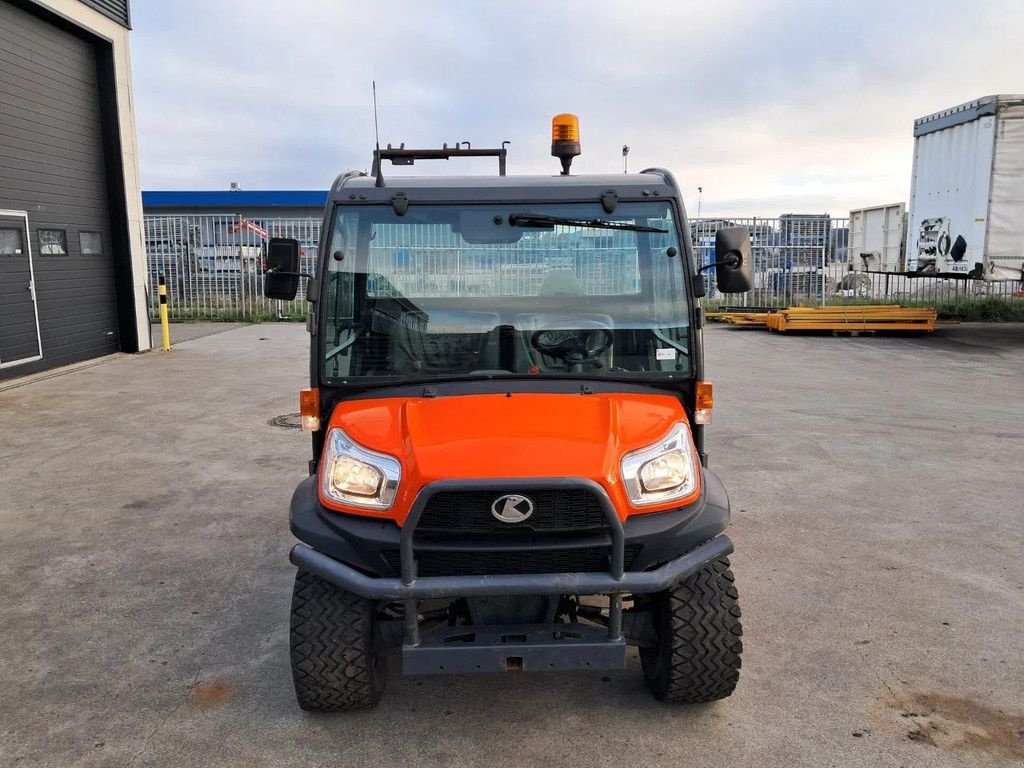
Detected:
[132,0,1024,217]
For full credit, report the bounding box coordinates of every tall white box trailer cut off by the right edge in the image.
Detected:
[906,95,1024,281]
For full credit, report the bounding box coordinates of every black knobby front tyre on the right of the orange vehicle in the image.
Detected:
[640,557,743,703]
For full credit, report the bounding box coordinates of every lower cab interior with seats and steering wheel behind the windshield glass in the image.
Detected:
[325,269,689,379]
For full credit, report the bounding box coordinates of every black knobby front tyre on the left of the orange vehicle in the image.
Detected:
[291,570,385,712]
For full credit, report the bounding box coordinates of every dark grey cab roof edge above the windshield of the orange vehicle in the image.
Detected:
[331,169,678,202]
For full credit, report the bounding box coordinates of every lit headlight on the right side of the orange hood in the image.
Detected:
[622,422,698,506]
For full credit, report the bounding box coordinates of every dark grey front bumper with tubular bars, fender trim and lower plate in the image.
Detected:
[291,470,732,675]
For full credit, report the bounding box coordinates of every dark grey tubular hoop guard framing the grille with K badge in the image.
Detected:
[398,477,626,647]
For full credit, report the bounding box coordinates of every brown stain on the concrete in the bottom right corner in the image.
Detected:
[873,691,1024,758]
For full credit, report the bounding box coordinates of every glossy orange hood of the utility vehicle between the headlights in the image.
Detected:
[329,393,699,524]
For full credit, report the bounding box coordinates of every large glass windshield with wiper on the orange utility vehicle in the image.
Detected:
[319,201,690,383]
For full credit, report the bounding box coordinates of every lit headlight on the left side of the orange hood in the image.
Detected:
[321,428,401,510]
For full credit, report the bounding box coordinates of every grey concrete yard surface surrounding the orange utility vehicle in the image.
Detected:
[0,325,1024,768]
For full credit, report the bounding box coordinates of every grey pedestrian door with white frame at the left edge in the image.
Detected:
[0,210,42,368]
